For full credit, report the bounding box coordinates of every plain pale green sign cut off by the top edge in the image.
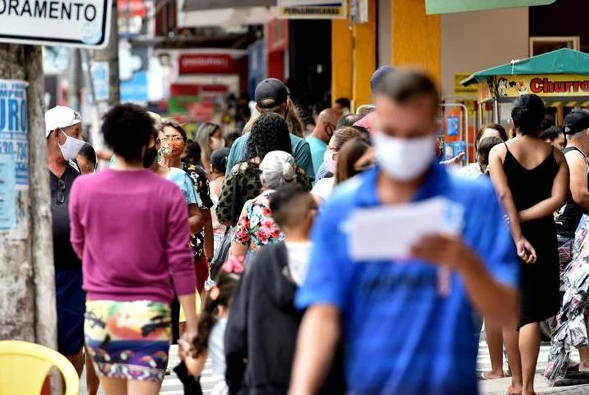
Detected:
[425,0,556,14]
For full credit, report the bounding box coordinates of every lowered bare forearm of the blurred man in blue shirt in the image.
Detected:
[289,305,341,395]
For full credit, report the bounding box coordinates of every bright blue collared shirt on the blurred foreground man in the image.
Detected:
[296,164,519,395]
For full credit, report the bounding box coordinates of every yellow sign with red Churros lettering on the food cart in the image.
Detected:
[479,75,589,100]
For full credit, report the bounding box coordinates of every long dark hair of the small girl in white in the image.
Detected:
[194,270,239,358]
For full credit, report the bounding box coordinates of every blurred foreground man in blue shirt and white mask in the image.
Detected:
[290,71,519,395]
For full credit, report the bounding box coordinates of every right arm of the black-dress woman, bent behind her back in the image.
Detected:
[519,151,568,222]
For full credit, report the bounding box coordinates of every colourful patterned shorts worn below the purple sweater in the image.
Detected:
[84,300,171,382]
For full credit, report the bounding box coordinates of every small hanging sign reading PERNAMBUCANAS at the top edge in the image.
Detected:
[278,0,348,19]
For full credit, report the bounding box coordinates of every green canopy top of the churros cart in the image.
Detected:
[461,48,589,86]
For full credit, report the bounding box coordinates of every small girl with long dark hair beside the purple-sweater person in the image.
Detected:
[179,270,240,395]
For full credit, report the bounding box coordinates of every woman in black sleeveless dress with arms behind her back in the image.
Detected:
[489,95,569,395]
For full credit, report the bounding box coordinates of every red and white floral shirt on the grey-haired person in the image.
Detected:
[233,190,284,253]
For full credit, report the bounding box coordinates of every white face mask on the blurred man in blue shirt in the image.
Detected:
[372,133,437,181]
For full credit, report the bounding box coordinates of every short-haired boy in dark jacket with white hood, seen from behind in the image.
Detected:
[225,183,343,395]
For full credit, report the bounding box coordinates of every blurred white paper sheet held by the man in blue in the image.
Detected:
[348,198,464,261]
